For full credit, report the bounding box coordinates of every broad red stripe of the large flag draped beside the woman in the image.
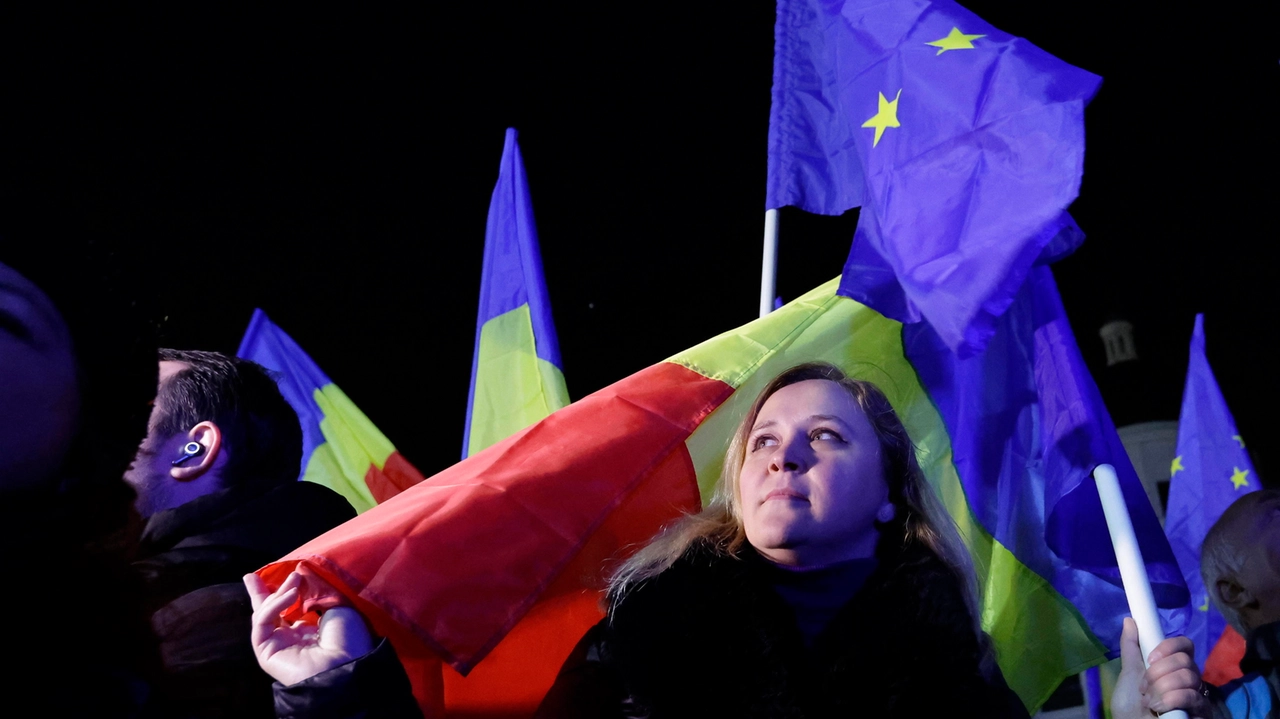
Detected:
[261,362,733,709]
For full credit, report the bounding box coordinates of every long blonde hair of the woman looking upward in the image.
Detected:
[609,362,980,632]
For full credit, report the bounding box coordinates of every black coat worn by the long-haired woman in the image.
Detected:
[539,537,1027,719]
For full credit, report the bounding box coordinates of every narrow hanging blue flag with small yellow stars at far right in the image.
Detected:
[1165,315,1261,683]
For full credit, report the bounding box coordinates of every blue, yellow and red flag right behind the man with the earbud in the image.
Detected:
[236,310,422,512]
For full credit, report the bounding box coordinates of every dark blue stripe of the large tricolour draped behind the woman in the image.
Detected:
[906,265,1188,665]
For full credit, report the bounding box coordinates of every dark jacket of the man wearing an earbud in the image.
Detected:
[134,482,356,719]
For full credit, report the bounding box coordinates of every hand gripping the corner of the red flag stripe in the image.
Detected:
[244,572,374,684]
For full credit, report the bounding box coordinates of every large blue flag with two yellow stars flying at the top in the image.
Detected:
[765,0,1101,356]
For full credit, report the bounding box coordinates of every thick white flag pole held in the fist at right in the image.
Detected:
[1093,464,1187,719]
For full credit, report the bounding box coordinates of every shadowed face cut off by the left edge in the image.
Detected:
[0,259,79,489]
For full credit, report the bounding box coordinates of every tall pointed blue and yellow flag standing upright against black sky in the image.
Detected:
[462,128,568,459]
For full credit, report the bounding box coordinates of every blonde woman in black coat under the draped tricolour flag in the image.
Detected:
[539,363,1025,716]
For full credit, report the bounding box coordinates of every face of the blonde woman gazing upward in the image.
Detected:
[739,380,892,567]
